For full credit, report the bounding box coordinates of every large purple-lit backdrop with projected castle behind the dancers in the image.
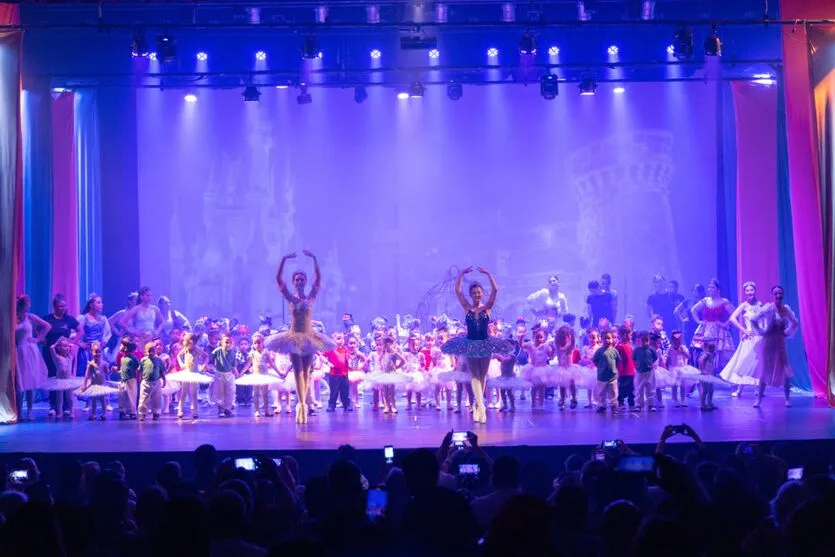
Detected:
[137,83,717,325]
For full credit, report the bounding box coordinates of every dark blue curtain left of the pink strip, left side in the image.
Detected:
[21,85,53,315]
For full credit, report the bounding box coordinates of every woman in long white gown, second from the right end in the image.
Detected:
[720,281,762,396]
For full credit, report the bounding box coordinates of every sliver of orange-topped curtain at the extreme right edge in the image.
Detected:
[815,73,835,405]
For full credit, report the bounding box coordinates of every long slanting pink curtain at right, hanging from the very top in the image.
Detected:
[780,0,832,402]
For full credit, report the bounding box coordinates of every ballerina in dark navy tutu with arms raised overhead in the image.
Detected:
[441,267,513,424]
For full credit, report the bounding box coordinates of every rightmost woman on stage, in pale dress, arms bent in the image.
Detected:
[751,286,799,408]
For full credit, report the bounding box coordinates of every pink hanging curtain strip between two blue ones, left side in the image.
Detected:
[52,93,80,315]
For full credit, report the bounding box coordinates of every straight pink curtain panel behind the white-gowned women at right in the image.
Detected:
[731,81,779,298]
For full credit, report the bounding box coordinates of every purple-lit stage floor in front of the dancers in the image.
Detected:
[0,392,835,453]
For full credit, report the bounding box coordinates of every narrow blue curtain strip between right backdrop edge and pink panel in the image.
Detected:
[716,82,739,301]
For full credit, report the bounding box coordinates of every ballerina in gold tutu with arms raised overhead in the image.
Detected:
[266,250,336,424]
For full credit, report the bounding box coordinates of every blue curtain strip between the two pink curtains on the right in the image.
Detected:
[777,76,812,391]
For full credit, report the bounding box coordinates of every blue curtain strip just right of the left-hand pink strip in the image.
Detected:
[74,89,102,305]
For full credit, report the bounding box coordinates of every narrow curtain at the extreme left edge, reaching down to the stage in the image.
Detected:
[0,4,23,424]
